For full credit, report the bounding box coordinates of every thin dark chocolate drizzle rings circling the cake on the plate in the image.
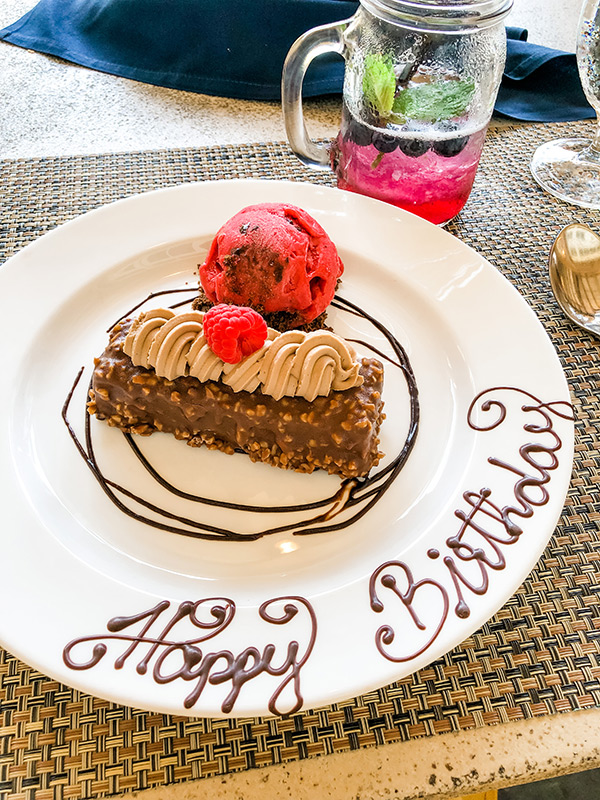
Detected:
[62,289,419,542]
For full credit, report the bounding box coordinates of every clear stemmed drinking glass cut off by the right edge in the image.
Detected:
[531,0,600,208]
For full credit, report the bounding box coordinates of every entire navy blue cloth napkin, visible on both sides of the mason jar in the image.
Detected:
[0,0,595,122]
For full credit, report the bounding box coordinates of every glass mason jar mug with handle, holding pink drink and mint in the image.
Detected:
[282,0,513,224]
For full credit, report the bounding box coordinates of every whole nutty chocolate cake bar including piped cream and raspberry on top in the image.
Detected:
[89,305,383,477]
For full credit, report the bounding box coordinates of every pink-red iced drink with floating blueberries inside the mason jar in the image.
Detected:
[332,108,487,225]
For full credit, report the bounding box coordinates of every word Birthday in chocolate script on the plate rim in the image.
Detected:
[369,386,573,662]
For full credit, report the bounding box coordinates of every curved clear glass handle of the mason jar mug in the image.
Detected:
[281,19,350,169]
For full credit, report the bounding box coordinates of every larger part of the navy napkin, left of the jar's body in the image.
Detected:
[0,0,358,100]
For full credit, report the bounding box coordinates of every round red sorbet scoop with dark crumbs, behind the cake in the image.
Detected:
[200,203,344,323]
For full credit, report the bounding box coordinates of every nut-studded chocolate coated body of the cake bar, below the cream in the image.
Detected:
[88,320,384,478]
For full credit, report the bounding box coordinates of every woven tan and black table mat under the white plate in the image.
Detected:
[0,123,600,800]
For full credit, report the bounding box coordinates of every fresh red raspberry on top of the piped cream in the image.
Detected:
[203,303,267,364]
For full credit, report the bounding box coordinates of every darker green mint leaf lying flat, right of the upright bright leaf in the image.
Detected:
[392,78,475,122]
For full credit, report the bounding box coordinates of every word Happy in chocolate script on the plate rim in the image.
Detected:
[63,596,317,714]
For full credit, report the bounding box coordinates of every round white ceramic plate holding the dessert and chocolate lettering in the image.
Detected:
[0,181,573,716]
